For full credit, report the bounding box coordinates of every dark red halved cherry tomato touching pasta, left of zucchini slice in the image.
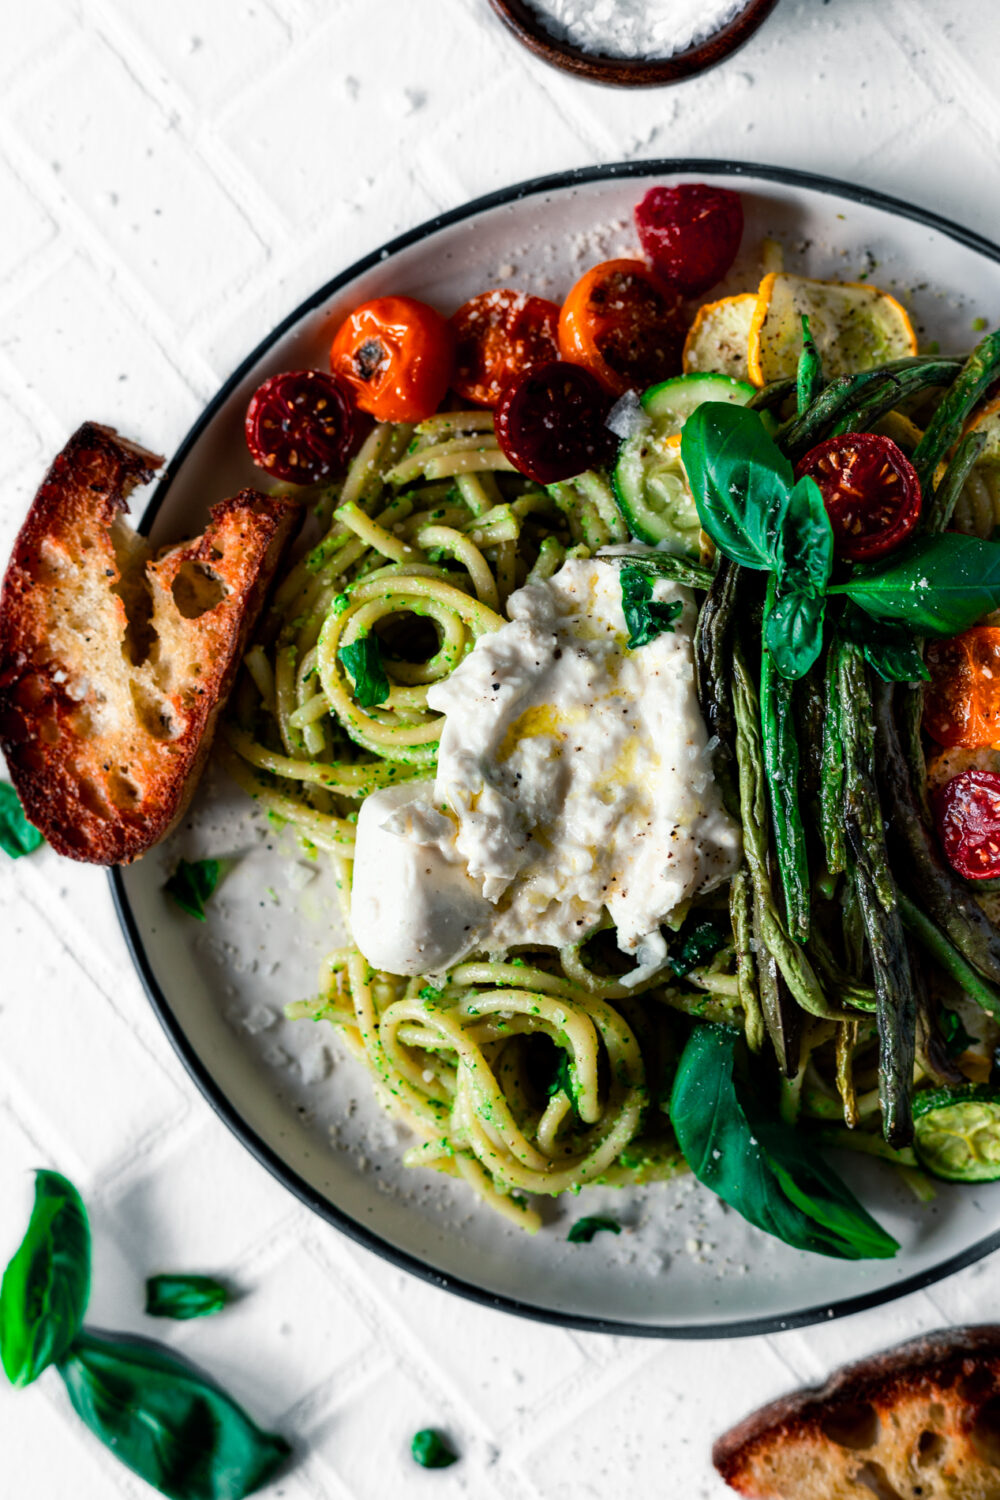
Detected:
[493,360,616,485]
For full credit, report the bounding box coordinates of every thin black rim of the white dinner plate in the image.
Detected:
[109,158,1000,1340]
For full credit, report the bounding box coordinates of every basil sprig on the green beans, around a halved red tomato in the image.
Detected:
[681,402,1000,681]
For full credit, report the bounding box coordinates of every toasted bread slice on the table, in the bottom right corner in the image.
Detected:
[712,1325,1000,1500]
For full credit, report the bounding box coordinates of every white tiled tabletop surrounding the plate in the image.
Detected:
[0,0,1000,1500]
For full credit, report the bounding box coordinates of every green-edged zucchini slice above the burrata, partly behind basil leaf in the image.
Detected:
[612,374,754,558]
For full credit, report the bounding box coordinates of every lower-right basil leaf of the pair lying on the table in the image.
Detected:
[58,1332,291,1500]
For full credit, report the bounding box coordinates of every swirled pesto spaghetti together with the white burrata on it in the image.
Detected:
[229,411,741,1230]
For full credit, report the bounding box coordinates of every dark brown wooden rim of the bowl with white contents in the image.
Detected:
[490,0,778,89]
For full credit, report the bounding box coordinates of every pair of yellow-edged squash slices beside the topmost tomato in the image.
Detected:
[747,272,916,386]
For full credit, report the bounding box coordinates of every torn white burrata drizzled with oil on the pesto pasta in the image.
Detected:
[351,560,741,983]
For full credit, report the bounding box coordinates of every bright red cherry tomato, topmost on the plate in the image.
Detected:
[636,183,744,297]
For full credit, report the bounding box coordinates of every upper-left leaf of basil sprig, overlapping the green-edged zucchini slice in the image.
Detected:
[681,401,795,569]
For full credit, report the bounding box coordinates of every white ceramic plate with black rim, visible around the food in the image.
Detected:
[112,161,1000,1338]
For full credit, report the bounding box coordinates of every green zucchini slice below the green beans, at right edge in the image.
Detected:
[913,1083,1000,1182]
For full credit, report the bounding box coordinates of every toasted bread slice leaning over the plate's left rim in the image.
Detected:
[0,423,298,864]
